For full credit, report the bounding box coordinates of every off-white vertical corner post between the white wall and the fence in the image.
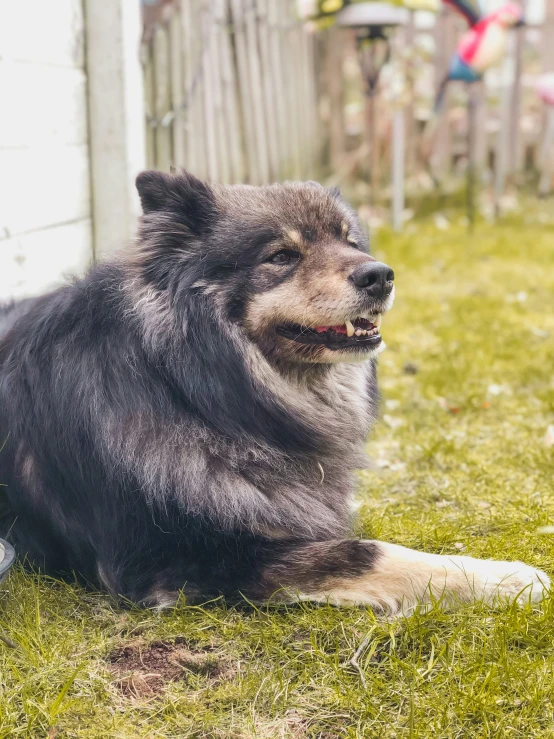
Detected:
[84,0,146,258]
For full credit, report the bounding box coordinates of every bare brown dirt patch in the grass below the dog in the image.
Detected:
[108,639,233,698]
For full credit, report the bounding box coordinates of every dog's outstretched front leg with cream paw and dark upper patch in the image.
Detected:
[251,540,550,616]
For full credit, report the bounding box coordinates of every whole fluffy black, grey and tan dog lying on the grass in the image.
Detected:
[0,172,549,615]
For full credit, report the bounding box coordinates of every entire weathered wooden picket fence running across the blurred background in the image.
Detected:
[142,0,554,207]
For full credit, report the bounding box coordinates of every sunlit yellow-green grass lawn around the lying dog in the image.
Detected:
[0,205,554,739]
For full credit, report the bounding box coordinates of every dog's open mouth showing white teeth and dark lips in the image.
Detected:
[277,313,383,350]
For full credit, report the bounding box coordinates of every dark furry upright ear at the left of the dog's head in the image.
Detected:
[136,169,215,231]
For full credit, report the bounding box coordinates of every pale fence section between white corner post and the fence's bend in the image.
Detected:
[142,0,320,184]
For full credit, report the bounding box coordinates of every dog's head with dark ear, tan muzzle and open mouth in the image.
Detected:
[137,172,394,363]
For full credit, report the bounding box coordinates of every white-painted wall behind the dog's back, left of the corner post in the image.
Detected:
[0,0,92,300]
